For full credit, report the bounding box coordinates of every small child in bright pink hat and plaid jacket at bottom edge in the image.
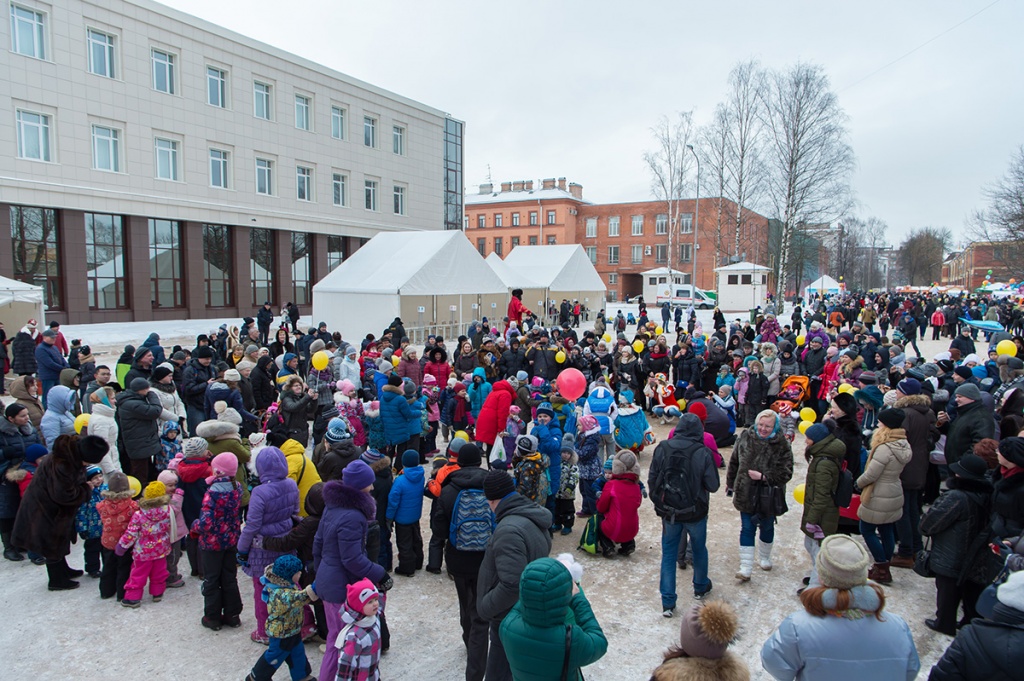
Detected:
[336,579,381,681]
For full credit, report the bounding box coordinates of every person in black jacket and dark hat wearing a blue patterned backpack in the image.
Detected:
[436,443,495,681]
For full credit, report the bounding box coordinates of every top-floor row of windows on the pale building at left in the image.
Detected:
[10,3,407,156]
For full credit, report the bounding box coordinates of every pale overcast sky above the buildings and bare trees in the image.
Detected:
[165,0,1024,244]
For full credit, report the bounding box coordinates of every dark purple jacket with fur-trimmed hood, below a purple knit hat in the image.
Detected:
[313,480,384,603]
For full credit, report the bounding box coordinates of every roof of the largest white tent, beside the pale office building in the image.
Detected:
[313,230,508,296]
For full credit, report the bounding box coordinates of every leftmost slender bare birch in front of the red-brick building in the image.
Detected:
[643,112,699,287]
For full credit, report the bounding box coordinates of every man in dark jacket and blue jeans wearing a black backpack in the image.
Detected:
[647,413,720,618]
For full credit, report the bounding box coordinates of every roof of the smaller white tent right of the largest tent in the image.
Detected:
[503,244,606,291]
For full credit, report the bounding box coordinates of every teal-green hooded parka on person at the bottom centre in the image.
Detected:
[499,558,608,681]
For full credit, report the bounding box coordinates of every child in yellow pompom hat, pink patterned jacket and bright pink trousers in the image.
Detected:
[114,481,175,607]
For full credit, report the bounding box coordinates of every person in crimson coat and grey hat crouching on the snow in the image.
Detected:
[597,450,641,558]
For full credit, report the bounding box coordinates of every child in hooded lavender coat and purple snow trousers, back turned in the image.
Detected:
[239,446,299,644]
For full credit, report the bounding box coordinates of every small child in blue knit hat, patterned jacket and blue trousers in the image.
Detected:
[246,554,316,681]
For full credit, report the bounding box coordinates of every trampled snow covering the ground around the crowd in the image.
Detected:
[0,321,950,681]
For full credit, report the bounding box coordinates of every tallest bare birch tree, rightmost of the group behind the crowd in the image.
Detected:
[761,62,854,298]
